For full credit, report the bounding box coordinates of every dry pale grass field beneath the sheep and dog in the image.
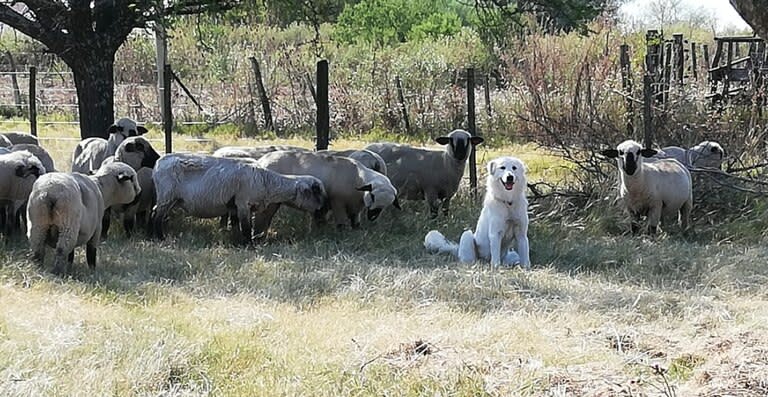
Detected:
[0,126,768,396]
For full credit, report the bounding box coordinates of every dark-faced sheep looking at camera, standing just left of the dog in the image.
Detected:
[365,130,483,217]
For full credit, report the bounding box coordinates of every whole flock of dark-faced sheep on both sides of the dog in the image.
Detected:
[0,114,724,274]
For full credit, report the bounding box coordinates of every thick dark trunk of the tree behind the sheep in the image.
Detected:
[68,52,115,139]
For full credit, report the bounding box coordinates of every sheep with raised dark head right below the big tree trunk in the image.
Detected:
[72,118,147,174]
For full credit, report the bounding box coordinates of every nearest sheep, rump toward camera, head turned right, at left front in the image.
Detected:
[27,163,141,274]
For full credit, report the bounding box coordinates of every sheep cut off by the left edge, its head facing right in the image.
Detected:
[0,150,46,233]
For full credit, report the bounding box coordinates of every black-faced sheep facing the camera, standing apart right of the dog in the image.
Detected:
[601,140,693,234]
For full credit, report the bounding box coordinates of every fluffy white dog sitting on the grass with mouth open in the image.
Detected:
[424,157,531,269]
